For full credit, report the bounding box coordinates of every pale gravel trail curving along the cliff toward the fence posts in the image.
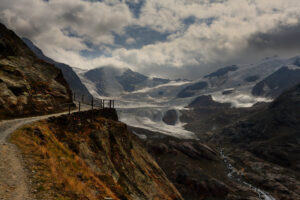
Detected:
[0,106,90,200]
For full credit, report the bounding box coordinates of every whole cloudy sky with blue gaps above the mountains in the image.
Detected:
[0,0,300,79]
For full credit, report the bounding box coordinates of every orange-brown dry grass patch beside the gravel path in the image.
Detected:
[11,122,118,200]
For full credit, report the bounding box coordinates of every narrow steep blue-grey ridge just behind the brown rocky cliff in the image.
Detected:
[22,38,92,99]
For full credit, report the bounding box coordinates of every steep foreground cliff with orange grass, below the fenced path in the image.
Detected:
[11,109,182,200]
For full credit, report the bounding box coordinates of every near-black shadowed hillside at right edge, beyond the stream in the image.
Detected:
[213,84,300,199]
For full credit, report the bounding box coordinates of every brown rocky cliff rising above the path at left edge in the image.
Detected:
[0,24,72,119]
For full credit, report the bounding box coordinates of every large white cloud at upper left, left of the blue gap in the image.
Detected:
[0,0,132,60]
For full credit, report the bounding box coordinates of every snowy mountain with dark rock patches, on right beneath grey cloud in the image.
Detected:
[177,57,300,106]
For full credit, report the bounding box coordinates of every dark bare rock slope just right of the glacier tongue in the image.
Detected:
[180,95,267,141]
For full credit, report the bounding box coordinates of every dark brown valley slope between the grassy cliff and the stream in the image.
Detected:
[130,127,258,200]
